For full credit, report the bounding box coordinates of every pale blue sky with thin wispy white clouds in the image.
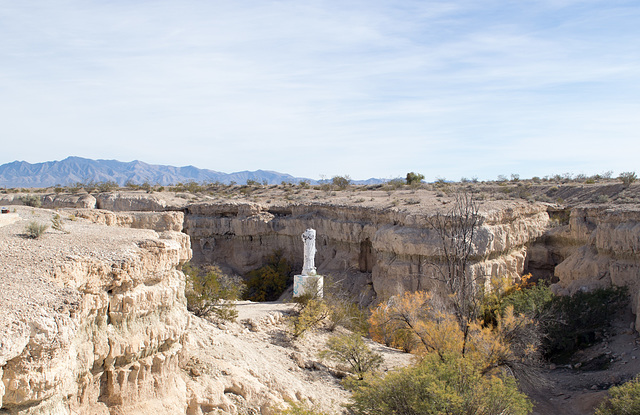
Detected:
[0,0,640,180]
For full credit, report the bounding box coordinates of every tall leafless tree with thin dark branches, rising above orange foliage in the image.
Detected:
[428,193,482,354]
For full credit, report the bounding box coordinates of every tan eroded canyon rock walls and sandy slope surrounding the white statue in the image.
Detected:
[0,186,640,414]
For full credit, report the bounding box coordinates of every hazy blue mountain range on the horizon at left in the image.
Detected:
[0,157,315,188]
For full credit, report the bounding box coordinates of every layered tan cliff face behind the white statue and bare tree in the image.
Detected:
[184,202,549,300]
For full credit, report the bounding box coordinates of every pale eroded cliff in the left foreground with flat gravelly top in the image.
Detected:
[0,210,191,414]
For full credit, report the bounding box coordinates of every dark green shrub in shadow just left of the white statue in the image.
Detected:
[244,251,291,301]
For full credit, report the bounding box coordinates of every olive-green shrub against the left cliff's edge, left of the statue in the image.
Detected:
[182,263,242,320]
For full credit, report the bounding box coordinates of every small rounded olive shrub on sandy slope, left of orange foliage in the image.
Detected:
[320,333,383,380]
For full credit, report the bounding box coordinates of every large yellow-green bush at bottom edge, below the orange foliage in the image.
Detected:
[348,355,532,415]
